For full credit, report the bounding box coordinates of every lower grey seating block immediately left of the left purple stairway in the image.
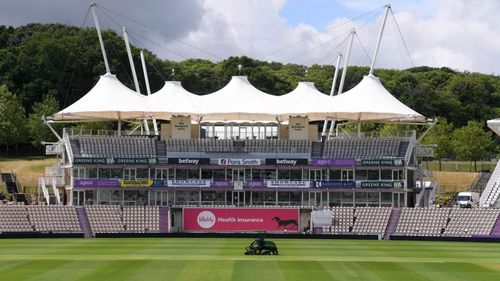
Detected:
[27,205,82,232]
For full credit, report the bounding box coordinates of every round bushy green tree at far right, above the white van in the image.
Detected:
[451,121,494,171]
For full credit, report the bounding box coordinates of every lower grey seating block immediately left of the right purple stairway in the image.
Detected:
[352,207,392,234]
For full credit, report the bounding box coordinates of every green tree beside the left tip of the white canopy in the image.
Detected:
[26,94,59,147]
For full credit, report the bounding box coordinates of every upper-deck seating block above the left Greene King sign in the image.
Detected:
[79,136,156,157]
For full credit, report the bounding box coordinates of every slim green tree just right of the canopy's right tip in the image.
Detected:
[423,117,454,171]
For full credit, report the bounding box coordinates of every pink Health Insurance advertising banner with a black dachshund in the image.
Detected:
[183,208,299,232]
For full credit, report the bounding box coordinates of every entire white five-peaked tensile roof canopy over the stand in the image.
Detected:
[53,74,426,122]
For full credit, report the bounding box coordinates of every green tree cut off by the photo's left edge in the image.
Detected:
[0,85,26,156]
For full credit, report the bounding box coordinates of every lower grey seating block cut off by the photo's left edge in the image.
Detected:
[0,202,33,232]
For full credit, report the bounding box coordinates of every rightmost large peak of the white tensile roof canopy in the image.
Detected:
[327,75,426,122]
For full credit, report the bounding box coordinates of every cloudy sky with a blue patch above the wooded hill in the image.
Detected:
[0,0,500,74]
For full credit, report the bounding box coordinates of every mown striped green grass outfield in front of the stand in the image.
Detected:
[0,238,500,281]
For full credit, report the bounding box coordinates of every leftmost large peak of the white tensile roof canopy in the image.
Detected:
[53,73,149,121]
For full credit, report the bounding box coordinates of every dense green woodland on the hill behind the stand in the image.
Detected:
[0,24,500,164]
